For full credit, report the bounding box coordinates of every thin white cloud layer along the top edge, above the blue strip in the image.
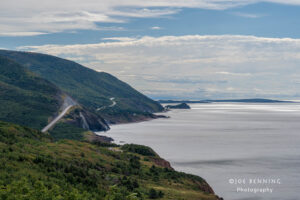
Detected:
[0,0,300,36]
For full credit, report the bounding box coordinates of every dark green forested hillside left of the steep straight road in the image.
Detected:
[0,57,60,129]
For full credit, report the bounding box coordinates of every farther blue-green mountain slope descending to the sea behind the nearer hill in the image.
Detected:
[0,50,163,123]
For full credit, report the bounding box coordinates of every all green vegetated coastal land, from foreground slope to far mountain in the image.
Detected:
[0,51,218,200]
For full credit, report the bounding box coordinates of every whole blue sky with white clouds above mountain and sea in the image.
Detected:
[0,0,300,100]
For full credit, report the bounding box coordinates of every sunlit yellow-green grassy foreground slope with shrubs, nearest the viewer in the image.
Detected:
[0,122,217,200]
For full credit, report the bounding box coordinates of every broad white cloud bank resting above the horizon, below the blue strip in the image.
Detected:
[20,35,300,98]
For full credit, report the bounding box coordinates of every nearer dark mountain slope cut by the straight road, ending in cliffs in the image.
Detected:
[0,56,109,138]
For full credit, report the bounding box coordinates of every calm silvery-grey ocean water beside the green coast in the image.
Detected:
[101,103,300,200]
